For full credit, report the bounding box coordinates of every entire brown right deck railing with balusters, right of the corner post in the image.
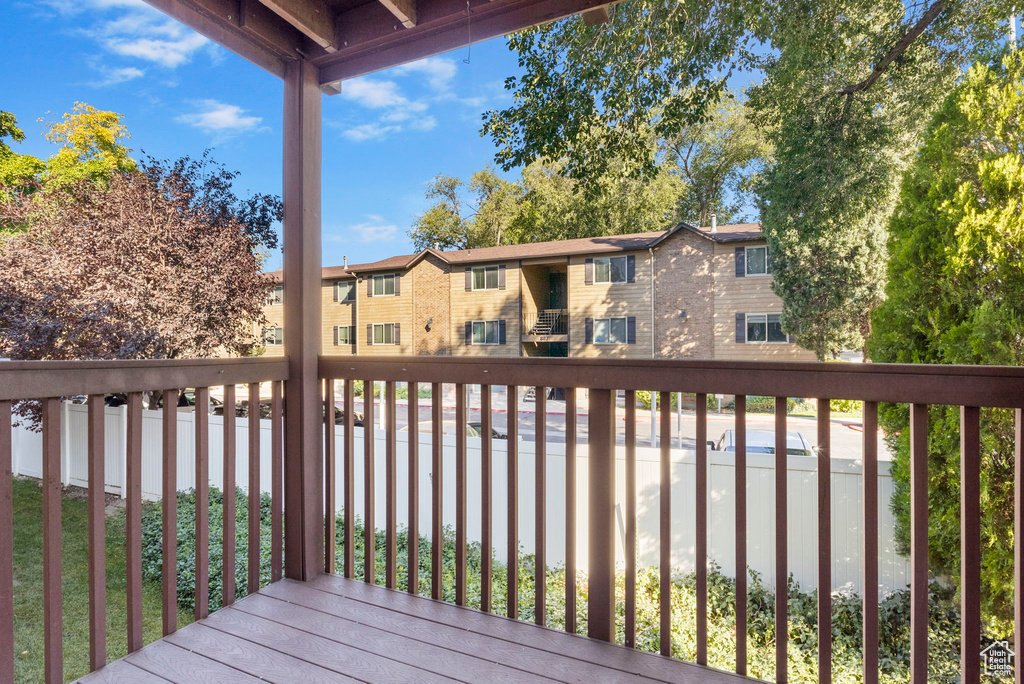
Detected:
[319,356,1024,684]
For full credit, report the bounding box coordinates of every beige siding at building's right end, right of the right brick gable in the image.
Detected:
[715,243,816,361]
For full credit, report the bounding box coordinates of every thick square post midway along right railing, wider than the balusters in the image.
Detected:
[589,389,615,641]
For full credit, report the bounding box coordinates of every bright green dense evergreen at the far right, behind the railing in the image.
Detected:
[869,51,1024,621]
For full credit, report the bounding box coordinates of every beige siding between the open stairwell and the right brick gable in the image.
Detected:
[568,252,651,358]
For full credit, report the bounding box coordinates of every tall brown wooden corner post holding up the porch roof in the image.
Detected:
[284,59,324,581]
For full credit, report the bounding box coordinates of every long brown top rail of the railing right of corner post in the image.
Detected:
[319,355,1024,408]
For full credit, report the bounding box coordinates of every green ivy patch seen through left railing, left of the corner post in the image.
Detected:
[142,487,270,610]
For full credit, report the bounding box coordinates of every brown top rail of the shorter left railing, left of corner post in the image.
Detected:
[0,357,288,401]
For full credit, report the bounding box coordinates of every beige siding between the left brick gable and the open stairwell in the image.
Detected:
[449,261,522,356]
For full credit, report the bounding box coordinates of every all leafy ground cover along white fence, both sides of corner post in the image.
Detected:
[142,497,997,684]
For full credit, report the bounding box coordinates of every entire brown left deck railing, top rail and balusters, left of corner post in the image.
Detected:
[0,358,288,682]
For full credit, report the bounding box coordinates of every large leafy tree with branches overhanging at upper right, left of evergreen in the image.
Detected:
[483,0,1013,357]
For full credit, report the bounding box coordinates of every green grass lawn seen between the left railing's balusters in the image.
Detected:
[13,479,191,682]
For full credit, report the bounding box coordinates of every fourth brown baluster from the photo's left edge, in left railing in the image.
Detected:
[125,392,142,653]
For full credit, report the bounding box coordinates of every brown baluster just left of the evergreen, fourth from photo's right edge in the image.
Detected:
[863,401,879,684]
